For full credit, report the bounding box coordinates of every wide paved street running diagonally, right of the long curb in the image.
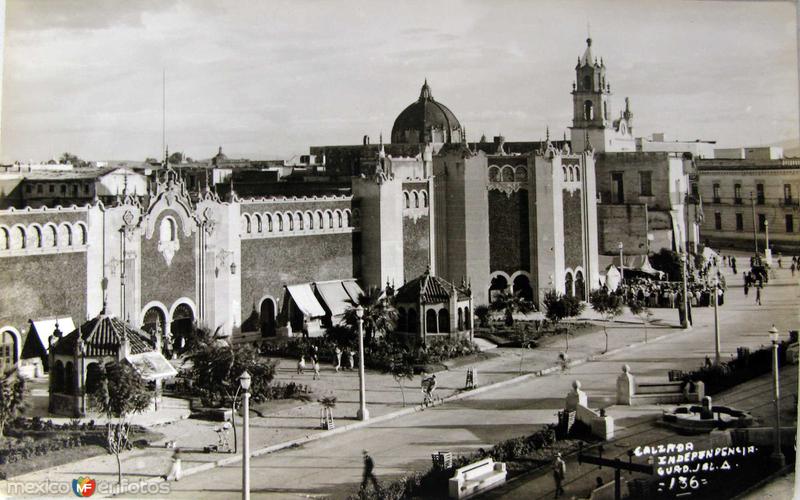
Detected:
[138,258,798,498]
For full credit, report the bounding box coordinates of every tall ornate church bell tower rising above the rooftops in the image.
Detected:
[570,38,636,153]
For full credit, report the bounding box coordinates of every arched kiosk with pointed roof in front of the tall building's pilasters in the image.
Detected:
[394,270,474,344]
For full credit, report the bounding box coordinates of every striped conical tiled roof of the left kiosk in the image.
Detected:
[53,313,154,356]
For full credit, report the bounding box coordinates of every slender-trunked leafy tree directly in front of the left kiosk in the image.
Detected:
[89,361,152,484]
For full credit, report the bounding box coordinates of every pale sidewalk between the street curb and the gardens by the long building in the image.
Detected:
[3,260,794,498]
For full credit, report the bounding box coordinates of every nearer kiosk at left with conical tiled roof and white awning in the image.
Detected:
[49,308,177,417]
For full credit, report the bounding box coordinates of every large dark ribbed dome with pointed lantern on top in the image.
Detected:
[392,80,462,144]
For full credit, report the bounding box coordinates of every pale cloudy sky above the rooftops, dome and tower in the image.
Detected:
[0,0,798,161]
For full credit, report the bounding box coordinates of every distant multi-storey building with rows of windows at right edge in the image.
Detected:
[697,148,800,254]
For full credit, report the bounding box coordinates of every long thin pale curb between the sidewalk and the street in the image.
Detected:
[106,324,670,498]
